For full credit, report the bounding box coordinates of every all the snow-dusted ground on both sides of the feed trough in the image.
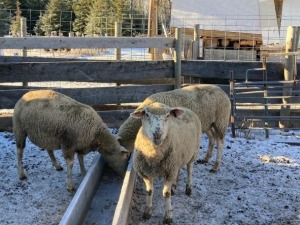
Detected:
[0,127,300,225]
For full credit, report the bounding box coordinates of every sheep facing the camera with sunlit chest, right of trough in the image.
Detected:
[131,102,202,224]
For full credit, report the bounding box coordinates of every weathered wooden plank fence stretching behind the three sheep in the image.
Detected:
[0,29,300,134]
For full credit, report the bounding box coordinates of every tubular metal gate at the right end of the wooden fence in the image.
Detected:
[230,71,300,138]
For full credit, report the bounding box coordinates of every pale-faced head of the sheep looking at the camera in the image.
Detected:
[130,102,184,146]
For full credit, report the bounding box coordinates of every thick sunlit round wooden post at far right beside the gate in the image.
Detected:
[279,26,300,129]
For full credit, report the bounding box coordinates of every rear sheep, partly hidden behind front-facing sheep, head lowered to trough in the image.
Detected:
[117,84,231,172]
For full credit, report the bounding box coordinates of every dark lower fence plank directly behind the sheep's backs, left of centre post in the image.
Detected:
[0,85,174,109]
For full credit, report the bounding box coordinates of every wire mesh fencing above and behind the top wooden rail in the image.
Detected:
[0,9,300,61]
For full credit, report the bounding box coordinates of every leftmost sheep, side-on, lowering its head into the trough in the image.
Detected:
[13,90,129,192]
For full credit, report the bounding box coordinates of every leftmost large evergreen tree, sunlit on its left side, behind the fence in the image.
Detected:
[35,0,72,36]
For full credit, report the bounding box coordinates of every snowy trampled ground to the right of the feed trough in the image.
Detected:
[130,131,300,225]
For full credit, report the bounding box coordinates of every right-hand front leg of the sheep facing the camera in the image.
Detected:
[163,179,178,224]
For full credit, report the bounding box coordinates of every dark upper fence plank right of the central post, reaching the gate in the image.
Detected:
[181,60,288,81]
